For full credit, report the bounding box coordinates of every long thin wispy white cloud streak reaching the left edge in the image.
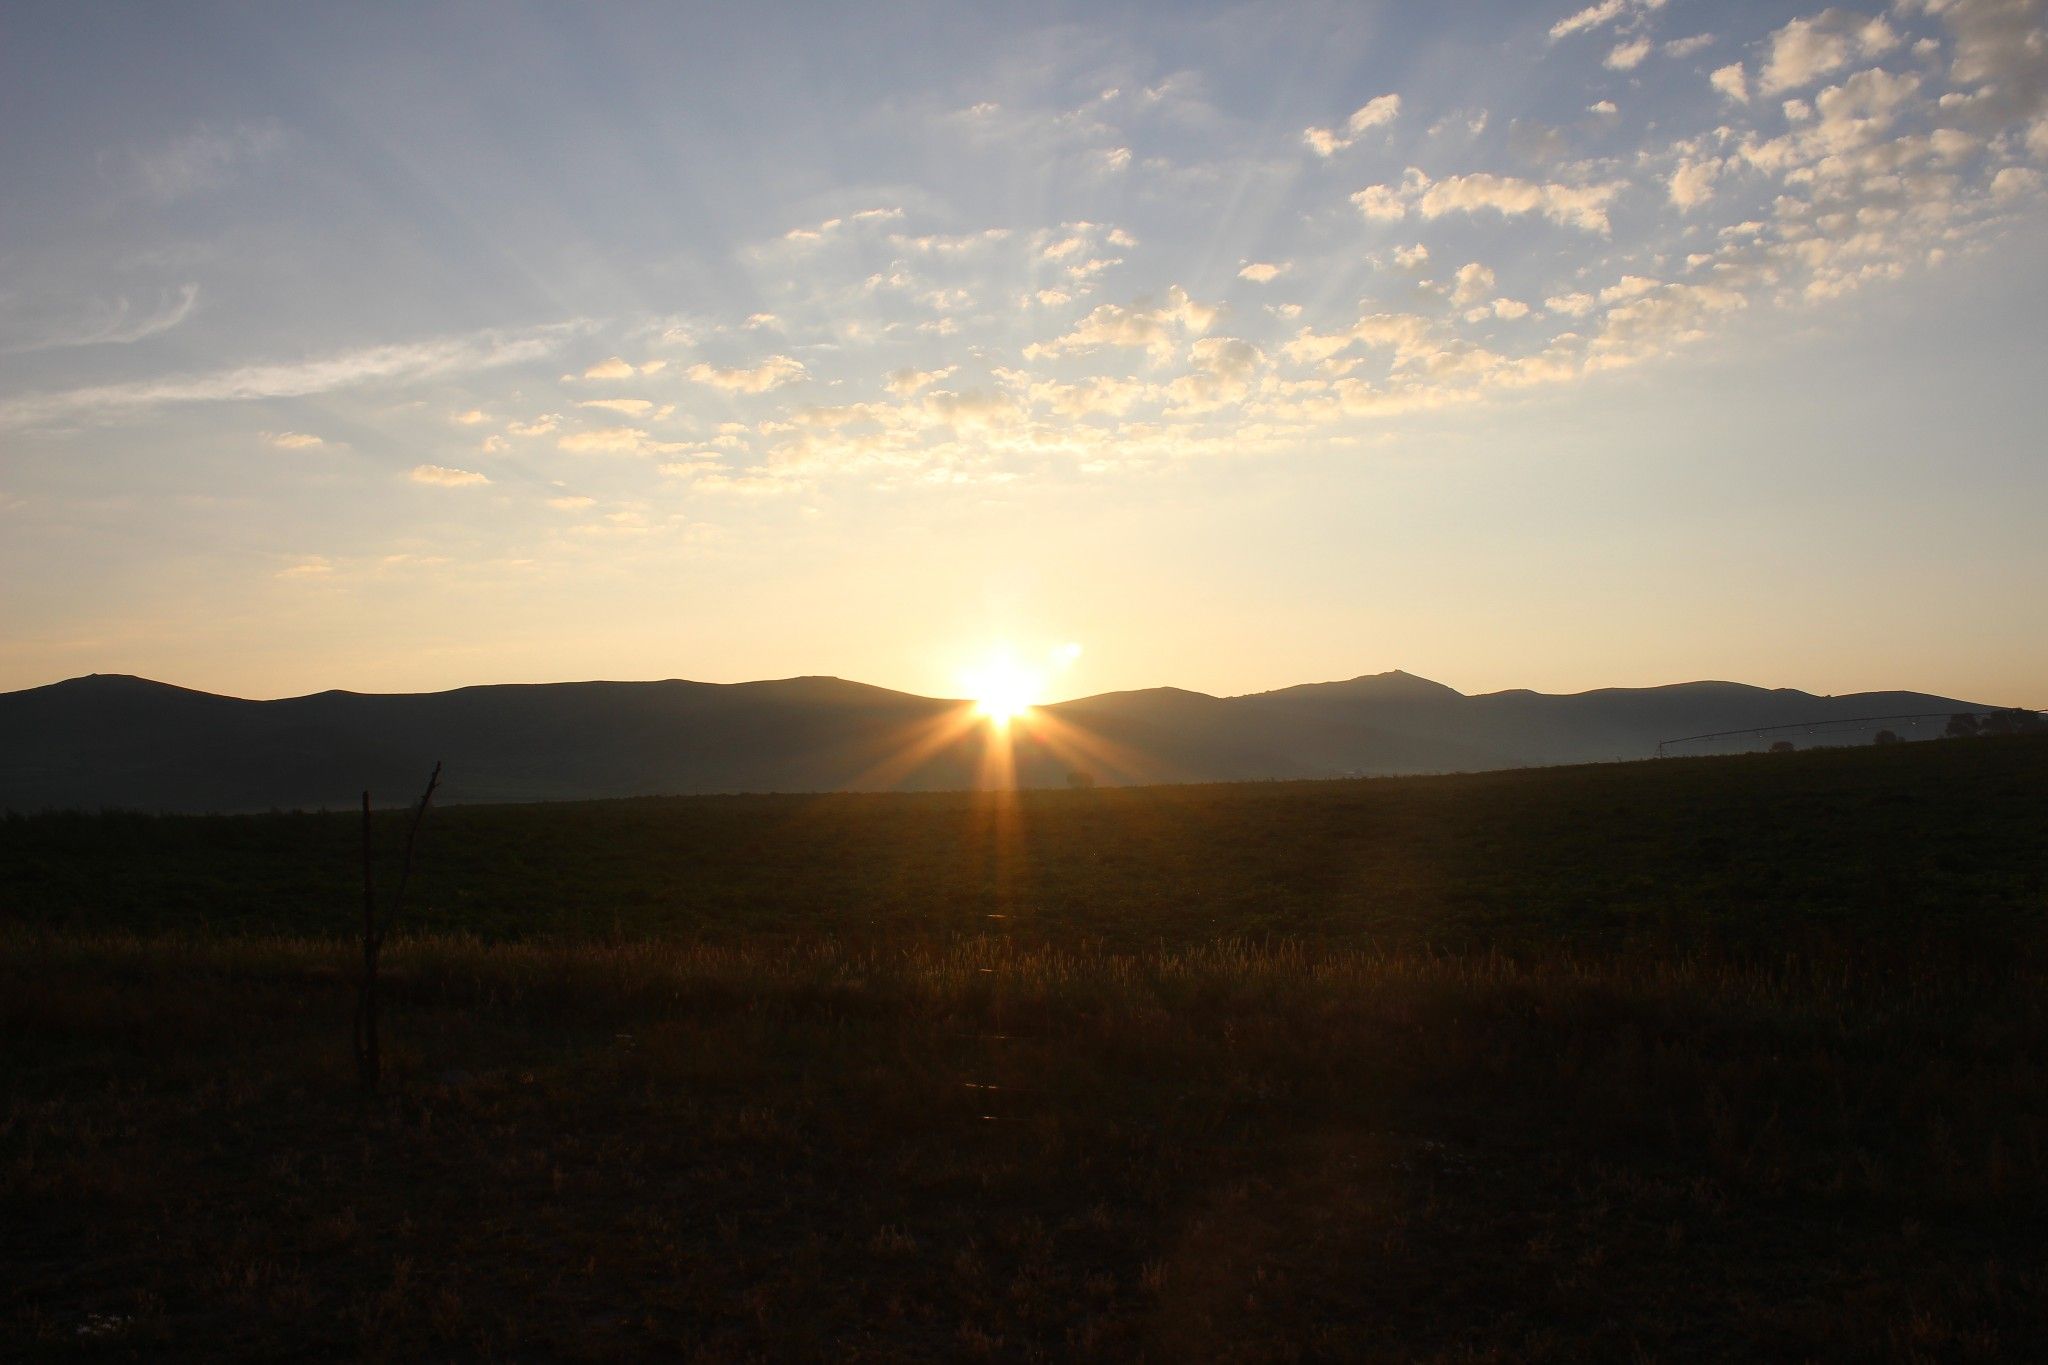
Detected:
[0,323,584,426]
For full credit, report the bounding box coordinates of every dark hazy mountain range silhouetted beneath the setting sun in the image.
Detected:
[0,671,2015,810]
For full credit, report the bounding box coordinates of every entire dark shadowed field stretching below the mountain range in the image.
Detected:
[0,739,2048,1361]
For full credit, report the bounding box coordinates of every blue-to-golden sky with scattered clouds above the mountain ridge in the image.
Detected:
[0,0,2048,706]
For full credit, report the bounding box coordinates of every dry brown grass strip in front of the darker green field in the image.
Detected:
[0,933,2048,1361]
